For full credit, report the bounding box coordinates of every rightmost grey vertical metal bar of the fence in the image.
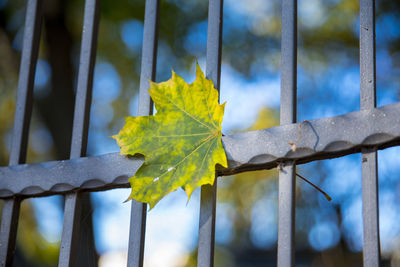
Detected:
[360,0,381,267]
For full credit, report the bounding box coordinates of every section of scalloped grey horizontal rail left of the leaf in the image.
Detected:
[0,153,138,197]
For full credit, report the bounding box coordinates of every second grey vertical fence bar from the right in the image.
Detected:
[278,0,297,267]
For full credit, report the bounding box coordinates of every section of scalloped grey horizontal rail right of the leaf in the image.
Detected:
[221,102,400,174]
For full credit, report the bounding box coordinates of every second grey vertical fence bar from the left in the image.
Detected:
[58,0,100,267]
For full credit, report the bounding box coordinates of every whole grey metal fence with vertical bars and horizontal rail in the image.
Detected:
[0,0,400,267]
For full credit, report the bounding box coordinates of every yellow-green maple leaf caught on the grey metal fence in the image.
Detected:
[113,65,227,209]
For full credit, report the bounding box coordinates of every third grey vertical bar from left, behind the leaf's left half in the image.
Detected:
[128,0,160,267]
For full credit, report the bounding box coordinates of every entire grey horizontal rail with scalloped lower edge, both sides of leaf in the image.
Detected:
[0,102,400,198]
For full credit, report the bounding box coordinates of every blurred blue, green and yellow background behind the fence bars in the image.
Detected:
[0,0,400,267]
